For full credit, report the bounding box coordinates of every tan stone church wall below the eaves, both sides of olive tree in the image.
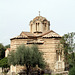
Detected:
[11,38,60,71]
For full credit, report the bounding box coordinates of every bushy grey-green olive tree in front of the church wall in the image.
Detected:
[8,45,45,75]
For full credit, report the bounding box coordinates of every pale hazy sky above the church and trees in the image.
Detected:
[0,0,75,45]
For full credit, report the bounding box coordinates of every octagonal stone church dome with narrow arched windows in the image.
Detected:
[30,15,50,33]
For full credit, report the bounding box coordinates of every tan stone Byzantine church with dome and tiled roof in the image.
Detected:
[6,15,65,72]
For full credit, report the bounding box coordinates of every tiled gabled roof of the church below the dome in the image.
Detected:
[10,30,61,40]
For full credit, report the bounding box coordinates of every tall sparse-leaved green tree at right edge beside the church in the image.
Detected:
[60,32,75,70]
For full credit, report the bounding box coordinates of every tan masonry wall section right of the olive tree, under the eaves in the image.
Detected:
[39,38,59,71]
